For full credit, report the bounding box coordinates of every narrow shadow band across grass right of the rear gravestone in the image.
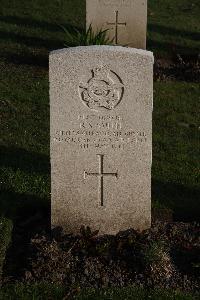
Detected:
[148,24,200,41]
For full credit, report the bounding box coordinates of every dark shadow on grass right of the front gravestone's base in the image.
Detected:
[152,180,200,222]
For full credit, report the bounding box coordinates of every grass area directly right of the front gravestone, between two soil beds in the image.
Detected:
[152,82,200,221]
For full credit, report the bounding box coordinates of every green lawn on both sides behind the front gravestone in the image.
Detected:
[0,0,200,299]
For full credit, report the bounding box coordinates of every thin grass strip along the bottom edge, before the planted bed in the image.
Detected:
[0,283,197,300]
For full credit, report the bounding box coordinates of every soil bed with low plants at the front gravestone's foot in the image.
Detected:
[3,212,200,293]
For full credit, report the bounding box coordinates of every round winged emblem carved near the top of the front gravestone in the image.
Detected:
[79,66,124,110]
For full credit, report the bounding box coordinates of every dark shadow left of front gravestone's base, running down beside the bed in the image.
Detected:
[0,190,50,279]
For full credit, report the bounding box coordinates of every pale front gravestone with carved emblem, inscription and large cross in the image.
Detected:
[50,46,153,234]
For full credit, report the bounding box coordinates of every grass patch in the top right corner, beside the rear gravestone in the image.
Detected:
[147,0,200,57]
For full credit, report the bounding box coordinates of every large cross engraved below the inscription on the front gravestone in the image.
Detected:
[84,154,118,206]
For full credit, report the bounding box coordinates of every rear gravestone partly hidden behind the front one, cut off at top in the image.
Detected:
[86,0,147,49]
